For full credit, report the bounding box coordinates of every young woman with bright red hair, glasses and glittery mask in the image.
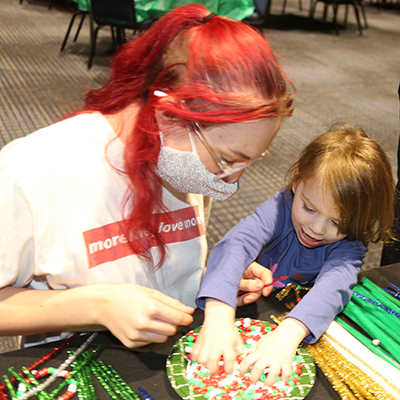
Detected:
[0,5,292,347]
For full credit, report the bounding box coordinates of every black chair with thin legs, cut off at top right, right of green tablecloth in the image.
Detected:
[310,0,368,35]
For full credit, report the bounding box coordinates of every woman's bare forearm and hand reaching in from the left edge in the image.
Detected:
[0,284,193,348]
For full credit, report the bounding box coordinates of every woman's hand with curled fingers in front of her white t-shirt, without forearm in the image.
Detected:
[94,284,194,348]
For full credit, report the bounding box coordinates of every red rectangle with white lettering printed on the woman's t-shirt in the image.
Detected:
[83,206,205,268]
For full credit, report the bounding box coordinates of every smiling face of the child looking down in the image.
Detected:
[292,179,346,248]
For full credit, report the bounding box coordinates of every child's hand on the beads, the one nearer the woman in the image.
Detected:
[190,299,243,374]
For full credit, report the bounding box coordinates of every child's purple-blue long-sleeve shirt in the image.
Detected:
[196,190,367,343]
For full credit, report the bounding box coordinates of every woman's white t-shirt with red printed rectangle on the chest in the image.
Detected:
[0,113,209,344]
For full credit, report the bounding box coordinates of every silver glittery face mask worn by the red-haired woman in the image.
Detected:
[158,134,238,200]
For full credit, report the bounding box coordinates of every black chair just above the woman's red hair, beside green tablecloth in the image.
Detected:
[88,0,153,69]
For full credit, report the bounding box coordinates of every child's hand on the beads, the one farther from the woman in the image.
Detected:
[239,318,310,386]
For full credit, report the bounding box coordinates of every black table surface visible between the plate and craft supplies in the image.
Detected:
[0,264,400,400]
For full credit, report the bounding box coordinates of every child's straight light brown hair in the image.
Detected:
[288,123,395,244]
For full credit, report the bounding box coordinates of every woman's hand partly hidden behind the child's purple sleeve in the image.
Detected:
[237,262,272,307]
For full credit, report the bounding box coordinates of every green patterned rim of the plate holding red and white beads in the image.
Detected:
[166,321,315,400]
